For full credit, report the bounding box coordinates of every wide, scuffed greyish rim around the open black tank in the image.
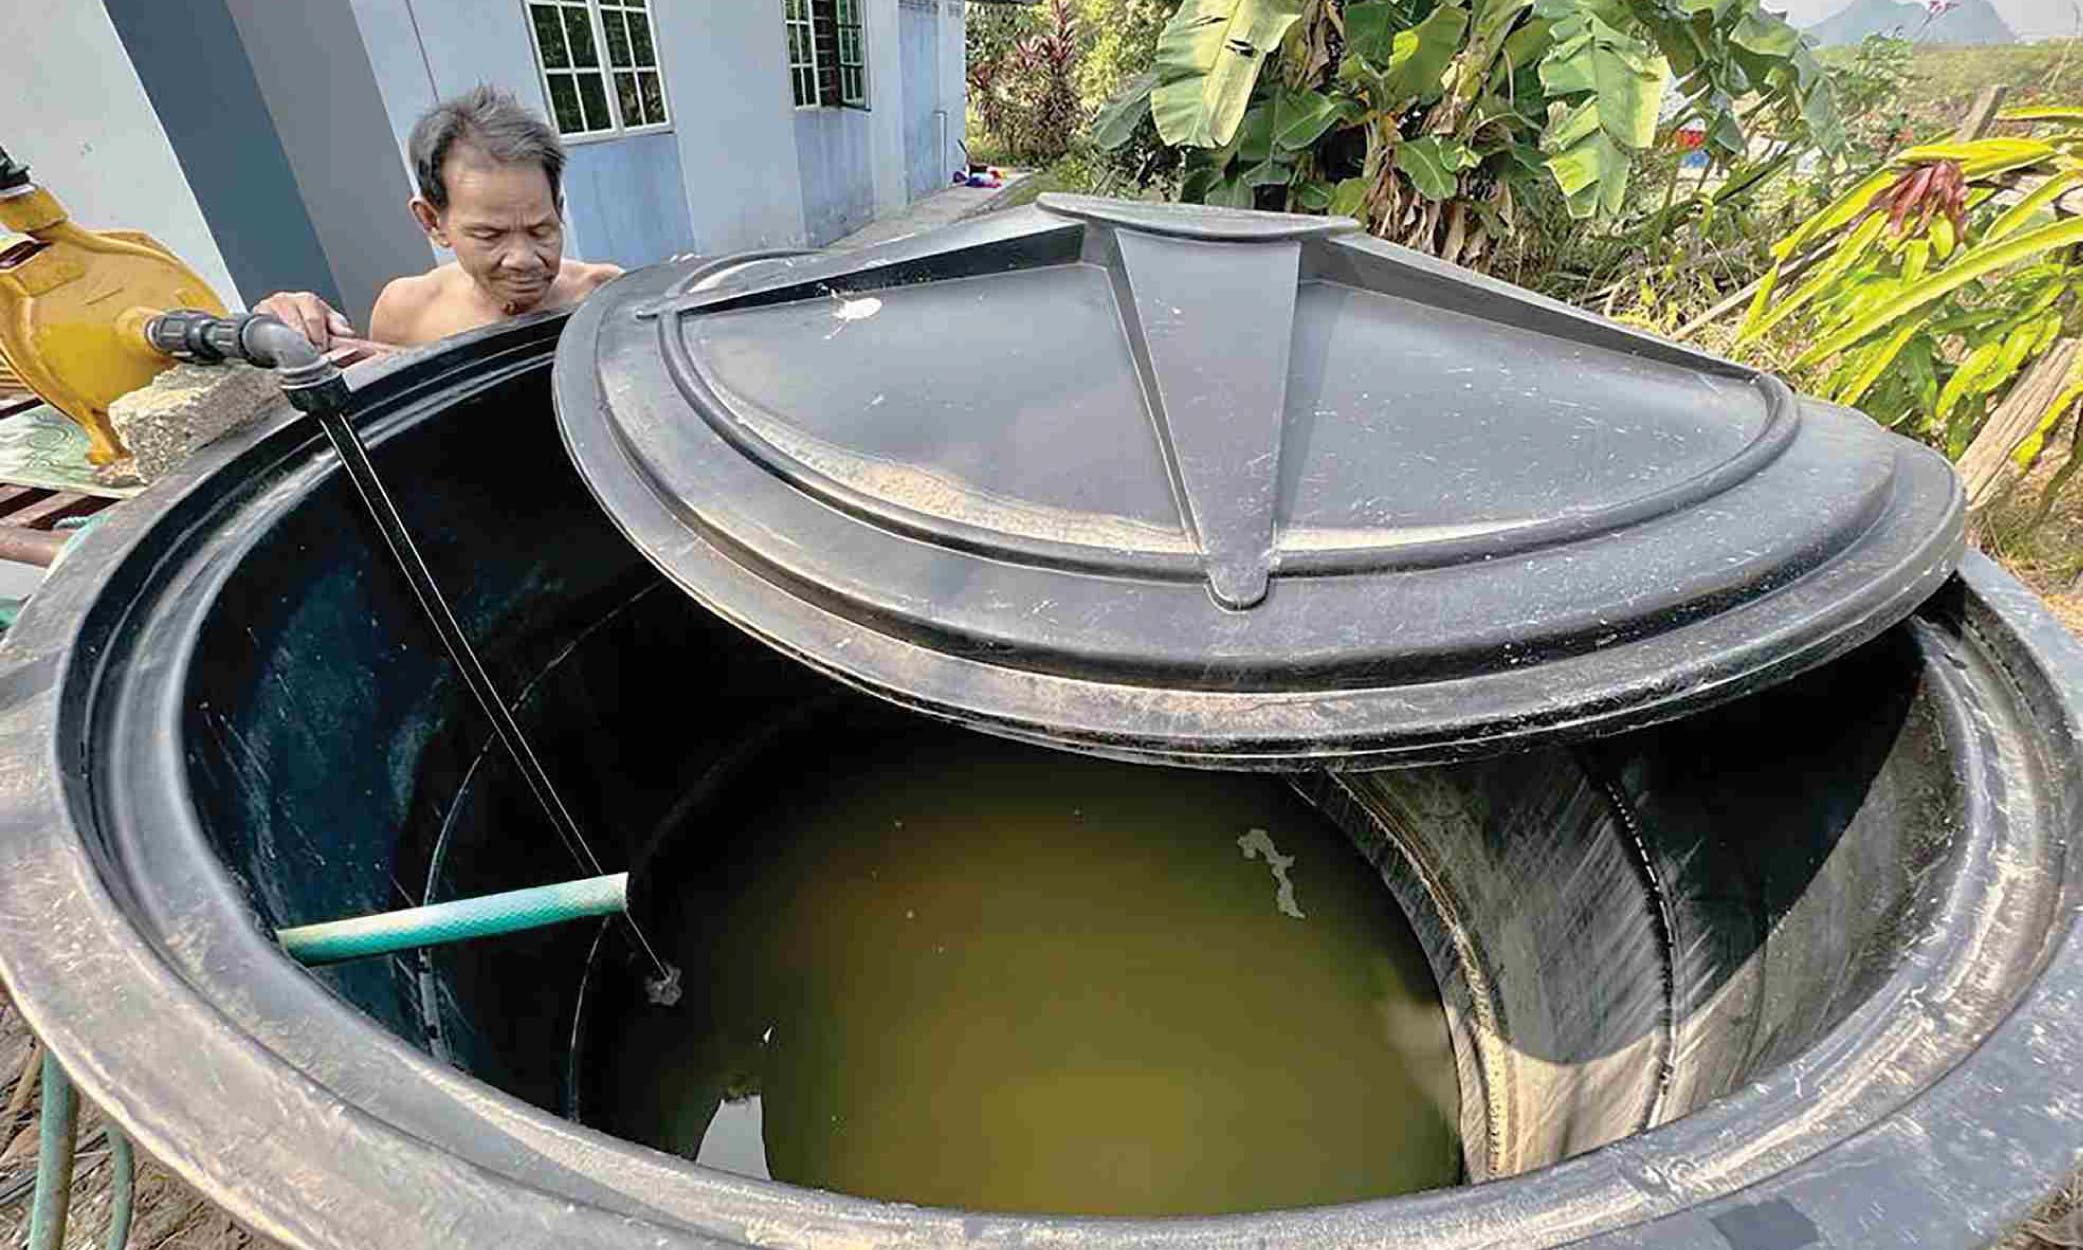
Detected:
[0,315,2083,1250]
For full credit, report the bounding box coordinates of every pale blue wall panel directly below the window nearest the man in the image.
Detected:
[564,133,694,269]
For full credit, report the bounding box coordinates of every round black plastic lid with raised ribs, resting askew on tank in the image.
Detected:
[556,196,1962,767]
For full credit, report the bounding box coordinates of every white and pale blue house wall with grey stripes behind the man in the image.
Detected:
[30,0,962,317]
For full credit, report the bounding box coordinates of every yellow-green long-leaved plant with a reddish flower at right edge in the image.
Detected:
[1737,108,2083,458]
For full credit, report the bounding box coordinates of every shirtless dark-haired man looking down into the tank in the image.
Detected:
[254,85,621,348]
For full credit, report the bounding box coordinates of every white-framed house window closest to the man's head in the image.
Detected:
[527,0,667,135]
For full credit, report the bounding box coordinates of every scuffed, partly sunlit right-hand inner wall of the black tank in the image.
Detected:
[1304,627,1964,1179]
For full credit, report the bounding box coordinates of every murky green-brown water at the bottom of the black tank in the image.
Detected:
[585,725,1460,1215]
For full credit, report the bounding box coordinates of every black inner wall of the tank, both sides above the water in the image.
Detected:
[166,365,1983,1179]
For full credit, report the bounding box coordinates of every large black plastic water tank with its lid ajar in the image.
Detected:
[0,204,2083,1250]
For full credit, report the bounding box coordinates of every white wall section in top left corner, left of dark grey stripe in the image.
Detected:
[0,0,240,302]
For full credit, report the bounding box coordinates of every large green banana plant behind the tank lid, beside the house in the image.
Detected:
[1094,0,1841,265]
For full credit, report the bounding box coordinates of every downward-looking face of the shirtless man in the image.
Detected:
[415,146,564,317]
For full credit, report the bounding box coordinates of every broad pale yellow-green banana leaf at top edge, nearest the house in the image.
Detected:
[1150,0,1304,148]
